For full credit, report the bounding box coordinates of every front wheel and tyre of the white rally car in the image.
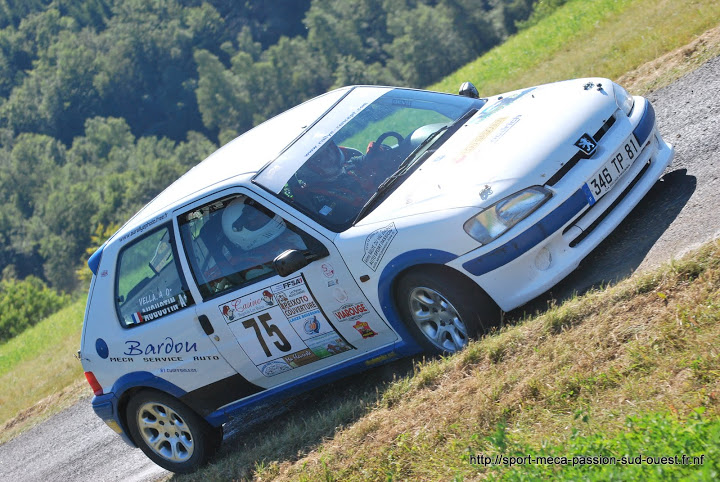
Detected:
[395,266,500,354]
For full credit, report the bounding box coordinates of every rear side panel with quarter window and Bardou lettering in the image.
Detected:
[107,223,233,392]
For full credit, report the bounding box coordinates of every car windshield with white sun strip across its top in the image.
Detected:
[255,87,484,232]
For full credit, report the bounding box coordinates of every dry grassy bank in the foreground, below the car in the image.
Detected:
[178,241,720,480]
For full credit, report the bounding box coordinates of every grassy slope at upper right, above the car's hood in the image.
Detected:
[431,0,720,96]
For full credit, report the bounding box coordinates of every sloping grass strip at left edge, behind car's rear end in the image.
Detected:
[0,298,89,441]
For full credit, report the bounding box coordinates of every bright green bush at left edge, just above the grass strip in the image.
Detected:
[0,276,69,343]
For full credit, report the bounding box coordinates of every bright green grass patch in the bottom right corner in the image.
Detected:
[486,408,720,480]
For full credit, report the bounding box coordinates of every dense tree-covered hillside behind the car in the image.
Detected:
[0,0,530,292]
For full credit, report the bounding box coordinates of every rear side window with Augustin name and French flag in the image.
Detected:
[115,225,193,327]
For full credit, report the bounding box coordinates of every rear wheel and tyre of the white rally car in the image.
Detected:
[126,390,222,474]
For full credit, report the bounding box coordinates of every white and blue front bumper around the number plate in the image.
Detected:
[448,99,674,311]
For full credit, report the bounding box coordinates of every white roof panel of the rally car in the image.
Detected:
[114,87,354,237]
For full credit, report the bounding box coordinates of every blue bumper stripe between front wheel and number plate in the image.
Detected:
[463,189,588,276]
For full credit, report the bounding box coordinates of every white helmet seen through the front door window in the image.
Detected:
[222,197,285,250]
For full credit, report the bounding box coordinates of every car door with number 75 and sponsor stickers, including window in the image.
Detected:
[176,188,397,388]
